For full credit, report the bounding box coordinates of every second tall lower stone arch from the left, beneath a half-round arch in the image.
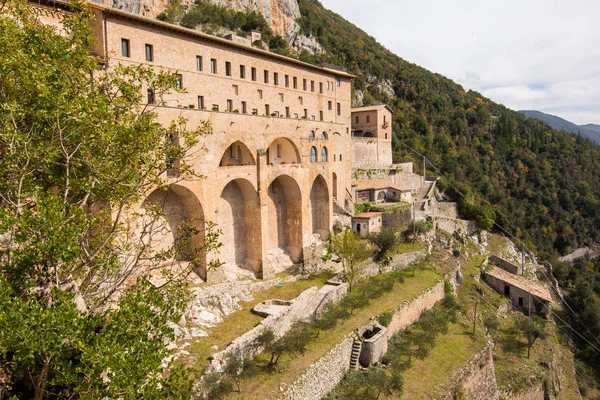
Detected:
[219,179,262,272]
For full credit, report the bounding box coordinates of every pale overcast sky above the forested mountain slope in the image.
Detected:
[321,0,600,124]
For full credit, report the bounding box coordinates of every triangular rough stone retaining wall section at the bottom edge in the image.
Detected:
[436,342,502,400]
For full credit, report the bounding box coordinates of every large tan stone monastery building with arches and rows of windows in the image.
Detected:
[30,3,424,281]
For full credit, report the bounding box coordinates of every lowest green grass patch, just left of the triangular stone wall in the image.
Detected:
[398,322,485,400]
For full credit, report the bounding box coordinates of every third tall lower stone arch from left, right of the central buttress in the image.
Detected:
[267,175,302,262]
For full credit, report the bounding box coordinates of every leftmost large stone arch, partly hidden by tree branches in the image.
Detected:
[137,185,206,279]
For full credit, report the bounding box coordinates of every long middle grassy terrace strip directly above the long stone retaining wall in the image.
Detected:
[229,269,440,399]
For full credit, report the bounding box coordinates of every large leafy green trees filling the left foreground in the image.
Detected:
[0,1,216,399]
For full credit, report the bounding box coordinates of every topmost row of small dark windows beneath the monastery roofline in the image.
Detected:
[121,39,341,93]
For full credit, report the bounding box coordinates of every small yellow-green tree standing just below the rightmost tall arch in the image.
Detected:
[331,228,371,291]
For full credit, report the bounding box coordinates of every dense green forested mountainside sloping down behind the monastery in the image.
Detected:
[292,0,600,260]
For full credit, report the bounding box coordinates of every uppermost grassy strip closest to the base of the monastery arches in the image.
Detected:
[186,273,333,369]
